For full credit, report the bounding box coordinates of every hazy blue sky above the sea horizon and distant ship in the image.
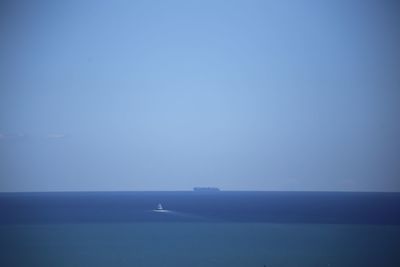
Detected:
[0,0,400,192]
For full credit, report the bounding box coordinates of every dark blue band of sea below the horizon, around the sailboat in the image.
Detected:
[0,191,400,225]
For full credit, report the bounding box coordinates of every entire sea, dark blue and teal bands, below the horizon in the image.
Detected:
[0,191,400,267]
